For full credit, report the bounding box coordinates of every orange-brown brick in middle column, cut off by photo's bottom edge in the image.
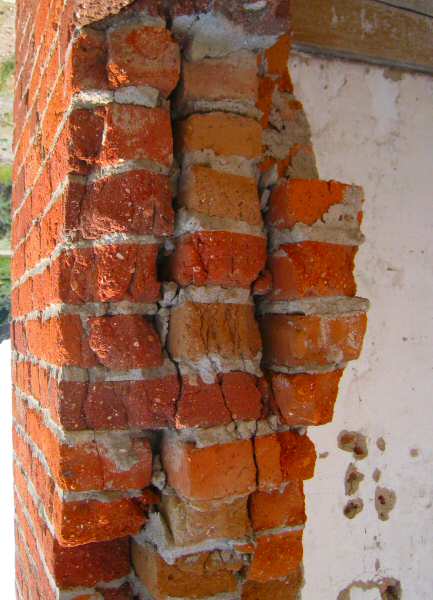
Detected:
[132,542,242,600]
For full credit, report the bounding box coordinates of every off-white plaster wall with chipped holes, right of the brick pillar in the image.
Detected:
[290,55,433,600]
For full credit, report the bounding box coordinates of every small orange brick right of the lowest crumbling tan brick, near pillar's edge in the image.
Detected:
[250,481,306,531]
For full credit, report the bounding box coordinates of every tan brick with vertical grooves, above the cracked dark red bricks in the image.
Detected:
[168,302,261,361]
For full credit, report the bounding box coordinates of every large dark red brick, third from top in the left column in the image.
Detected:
[81,171,174,239]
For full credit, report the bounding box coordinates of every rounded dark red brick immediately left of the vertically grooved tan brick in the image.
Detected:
[88,315,163,371]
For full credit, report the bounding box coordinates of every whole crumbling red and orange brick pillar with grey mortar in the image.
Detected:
[13,0,367,600]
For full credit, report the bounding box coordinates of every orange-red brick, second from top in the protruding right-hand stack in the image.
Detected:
[268,242,357,301]
